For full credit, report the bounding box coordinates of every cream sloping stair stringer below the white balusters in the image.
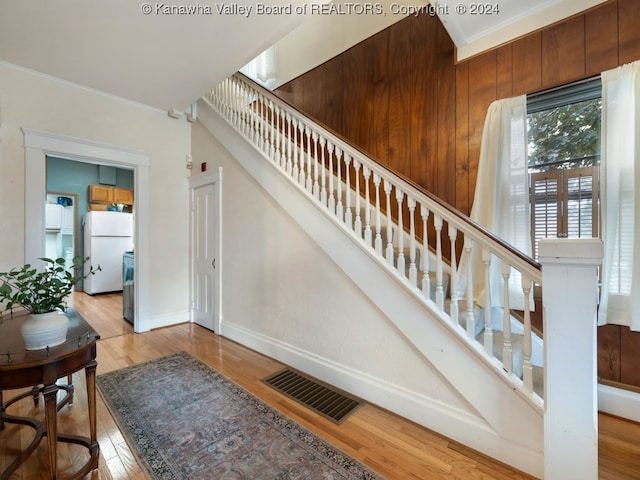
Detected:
[199,99,543,477]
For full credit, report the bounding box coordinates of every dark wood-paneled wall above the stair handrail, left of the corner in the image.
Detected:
[276,15,456,204]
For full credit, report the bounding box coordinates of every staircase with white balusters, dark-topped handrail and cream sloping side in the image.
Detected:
[199,74,604,476]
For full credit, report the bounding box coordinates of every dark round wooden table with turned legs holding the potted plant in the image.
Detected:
[0,309,100,480]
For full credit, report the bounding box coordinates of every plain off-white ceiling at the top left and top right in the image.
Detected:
[0,0,605,111]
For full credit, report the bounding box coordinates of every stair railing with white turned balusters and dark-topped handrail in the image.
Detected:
[203,74,542,406]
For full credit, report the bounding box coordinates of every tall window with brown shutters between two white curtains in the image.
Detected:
[527,77,601,259]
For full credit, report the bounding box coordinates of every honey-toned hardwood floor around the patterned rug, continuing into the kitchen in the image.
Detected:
[0,294,640,480]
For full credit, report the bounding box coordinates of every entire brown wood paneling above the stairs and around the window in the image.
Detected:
[276,0,640,386]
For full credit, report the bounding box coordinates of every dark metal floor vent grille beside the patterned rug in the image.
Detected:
[263,368,363,425]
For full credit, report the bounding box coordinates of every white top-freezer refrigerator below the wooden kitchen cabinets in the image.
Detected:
[82,211,133,295]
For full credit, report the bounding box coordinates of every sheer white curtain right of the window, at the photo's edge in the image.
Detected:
[598,62,640,331]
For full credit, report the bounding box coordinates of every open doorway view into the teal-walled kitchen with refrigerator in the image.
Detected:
[45,155,135,338]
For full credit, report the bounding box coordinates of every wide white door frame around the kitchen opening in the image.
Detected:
[22,128,151,332]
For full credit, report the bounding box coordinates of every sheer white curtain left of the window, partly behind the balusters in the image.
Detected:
[461,95,533,310]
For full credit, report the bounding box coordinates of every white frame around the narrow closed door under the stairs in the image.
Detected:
[189,167,223,335]
